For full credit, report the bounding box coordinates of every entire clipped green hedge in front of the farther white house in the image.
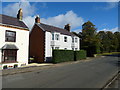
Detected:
[53,50,86,63]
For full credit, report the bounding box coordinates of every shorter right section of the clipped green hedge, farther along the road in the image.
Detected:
[74,50,86,61]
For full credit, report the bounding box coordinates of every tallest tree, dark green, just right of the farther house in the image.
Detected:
[81,21,100,56]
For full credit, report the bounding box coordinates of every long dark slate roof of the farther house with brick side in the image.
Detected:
[37,23,76,36]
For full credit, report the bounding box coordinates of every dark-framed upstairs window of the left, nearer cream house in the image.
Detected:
[5,30,16,42]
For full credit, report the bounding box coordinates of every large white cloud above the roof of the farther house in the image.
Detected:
[41,11,84,29]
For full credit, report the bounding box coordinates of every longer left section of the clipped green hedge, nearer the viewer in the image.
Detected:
[53,50,74,63]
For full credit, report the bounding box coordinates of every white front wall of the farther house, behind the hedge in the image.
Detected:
[45,31,79,62]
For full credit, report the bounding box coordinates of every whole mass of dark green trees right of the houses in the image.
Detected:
[74,21,120,56]
